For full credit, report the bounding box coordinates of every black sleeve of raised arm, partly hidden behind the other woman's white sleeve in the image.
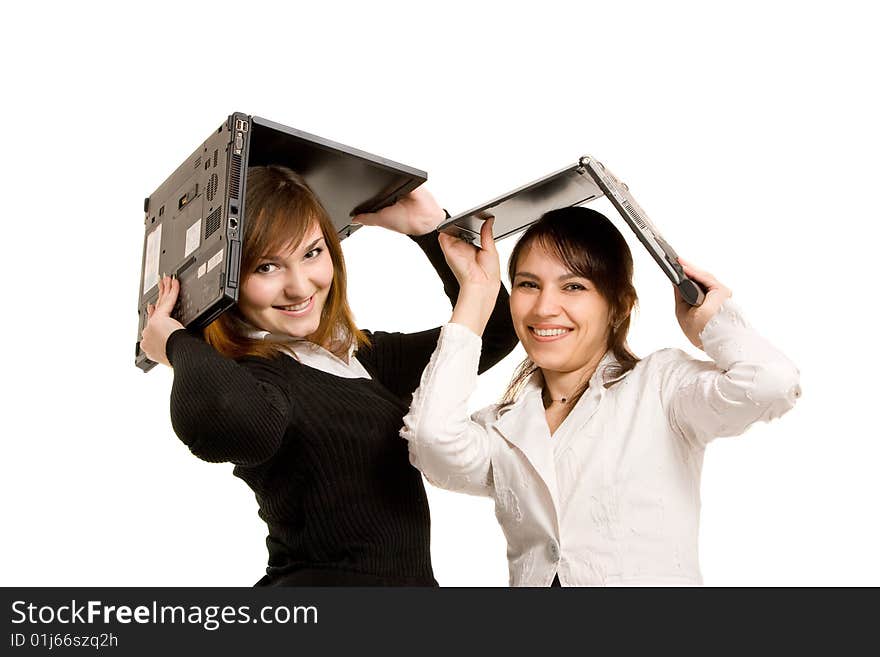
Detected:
[358,231,518,401]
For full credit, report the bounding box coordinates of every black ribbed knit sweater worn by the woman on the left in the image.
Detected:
[166,233,516,586]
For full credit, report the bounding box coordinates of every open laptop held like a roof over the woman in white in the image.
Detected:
[438,155,706,306]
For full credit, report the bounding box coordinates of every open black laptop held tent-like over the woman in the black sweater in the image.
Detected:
[135,112,428,372]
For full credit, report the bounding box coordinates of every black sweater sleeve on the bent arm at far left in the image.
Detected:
[165,330,291,465]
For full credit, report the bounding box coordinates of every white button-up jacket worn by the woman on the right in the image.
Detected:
[401,300,800,586]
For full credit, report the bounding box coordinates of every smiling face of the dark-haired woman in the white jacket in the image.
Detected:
[510,243,610,373]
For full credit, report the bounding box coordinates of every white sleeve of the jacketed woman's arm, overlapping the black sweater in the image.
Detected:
[400,323,493,496]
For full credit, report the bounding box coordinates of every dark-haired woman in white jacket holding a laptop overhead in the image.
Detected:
[401,207,800,586]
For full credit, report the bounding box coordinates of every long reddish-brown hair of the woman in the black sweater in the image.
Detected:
[204,165,368,358]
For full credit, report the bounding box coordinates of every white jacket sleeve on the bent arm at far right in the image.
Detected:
[661,299,801,446]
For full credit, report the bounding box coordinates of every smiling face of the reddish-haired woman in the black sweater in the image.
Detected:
[238,223,333,338]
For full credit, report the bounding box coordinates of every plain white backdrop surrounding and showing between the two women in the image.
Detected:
[0,1,880,586]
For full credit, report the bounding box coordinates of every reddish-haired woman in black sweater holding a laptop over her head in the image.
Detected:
[141,166,516,586]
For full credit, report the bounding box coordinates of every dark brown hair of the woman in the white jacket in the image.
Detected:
[502,207,639,407]
